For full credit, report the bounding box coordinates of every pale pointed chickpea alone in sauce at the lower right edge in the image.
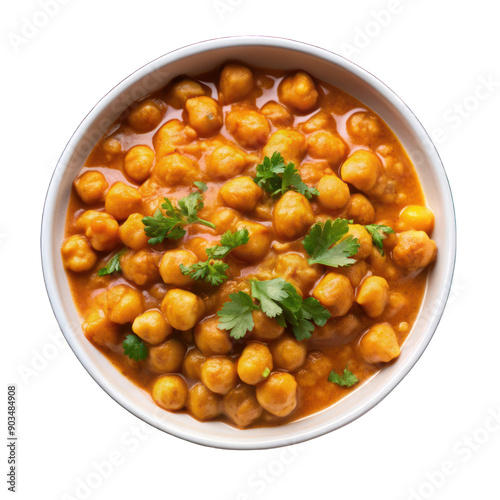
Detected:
[359,323,401,363]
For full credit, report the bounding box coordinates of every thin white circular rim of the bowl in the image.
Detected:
[40,35,456,450]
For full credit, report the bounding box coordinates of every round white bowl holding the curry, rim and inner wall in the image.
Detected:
[41,36,456,449]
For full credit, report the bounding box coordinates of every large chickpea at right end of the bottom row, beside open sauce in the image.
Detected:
[256,372,297,417]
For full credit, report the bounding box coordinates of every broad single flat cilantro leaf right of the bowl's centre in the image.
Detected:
[302,218,359,267]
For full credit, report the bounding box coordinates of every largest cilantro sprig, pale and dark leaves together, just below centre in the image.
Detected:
[217,278,331,340]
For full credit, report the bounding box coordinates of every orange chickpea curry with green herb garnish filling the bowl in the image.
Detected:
[61,63,437,428]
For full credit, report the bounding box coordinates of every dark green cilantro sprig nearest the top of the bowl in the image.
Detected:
[254,151,319,199]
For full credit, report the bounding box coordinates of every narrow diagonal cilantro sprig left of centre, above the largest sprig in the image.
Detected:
[179,229,249,286]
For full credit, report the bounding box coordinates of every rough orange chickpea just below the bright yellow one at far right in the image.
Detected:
[392,230,437,269]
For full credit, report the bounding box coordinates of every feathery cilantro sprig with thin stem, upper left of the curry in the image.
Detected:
[142,182,215,245]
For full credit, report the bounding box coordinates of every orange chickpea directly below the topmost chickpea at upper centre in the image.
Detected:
[226,109,271,149]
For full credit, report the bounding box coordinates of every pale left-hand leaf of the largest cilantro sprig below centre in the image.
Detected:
[217,292,258,339]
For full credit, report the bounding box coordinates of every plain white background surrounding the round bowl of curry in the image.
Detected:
[0,0,500,500]
